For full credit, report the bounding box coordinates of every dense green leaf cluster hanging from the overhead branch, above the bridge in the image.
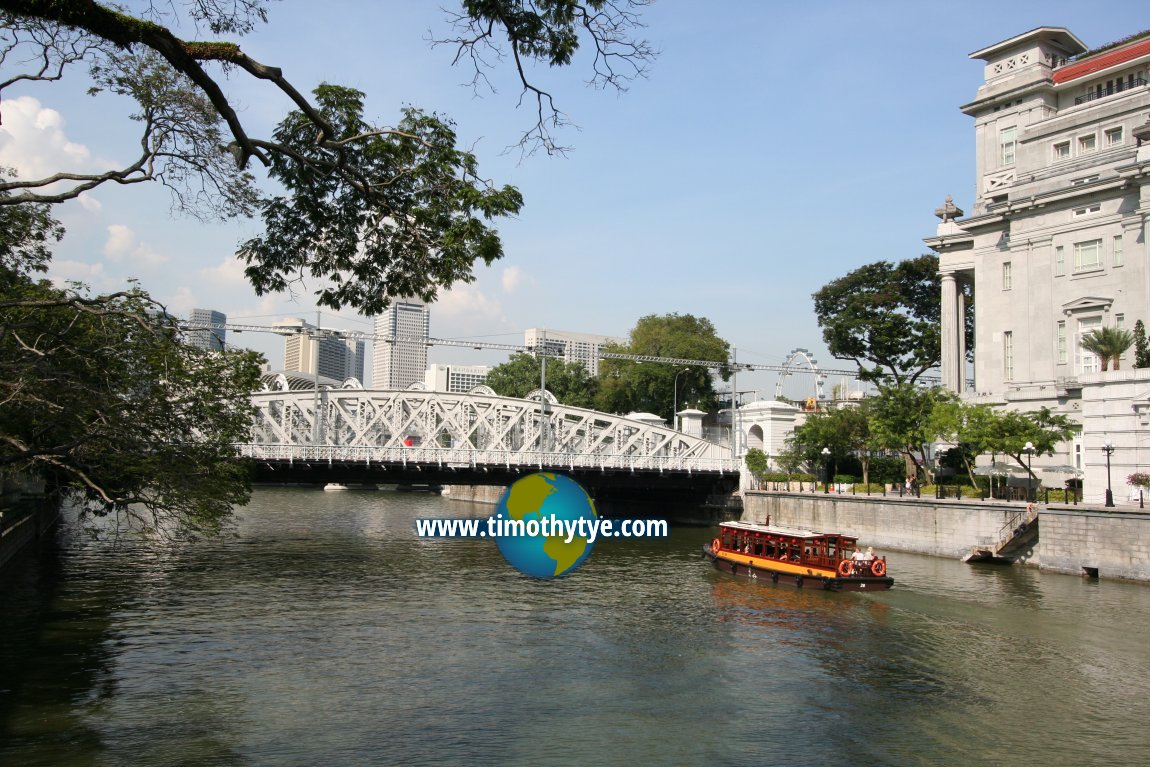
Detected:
[239,85,523,314]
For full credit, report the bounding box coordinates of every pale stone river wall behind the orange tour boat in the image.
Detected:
[743,491,1150,581]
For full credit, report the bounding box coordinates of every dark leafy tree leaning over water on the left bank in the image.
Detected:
[0,205,262,534]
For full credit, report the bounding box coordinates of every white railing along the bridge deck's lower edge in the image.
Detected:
[237,444,739,474]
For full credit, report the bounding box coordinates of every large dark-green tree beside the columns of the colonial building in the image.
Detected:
[813,255,974,384]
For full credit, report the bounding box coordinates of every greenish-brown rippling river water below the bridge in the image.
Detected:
[0,489,1150,767]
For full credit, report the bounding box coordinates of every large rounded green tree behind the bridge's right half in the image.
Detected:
[596,314,730,422]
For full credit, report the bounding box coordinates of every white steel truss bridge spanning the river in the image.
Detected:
[240,376,739,484]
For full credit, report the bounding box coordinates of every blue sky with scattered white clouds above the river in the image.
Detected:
[0,0,1148,399]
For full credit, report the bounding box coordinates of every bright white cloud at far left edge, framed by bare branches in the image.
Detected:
[0,95,92,178]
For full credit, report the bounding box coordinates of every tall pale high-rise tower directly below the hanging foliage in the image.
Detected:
[371,298,431,389]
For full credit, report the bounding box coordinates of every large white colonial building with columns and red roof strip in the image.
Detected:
[926,26,1150,501]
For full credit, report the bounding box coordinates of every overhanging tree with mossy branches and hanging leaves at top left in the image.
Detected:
[0,0,653,314]
